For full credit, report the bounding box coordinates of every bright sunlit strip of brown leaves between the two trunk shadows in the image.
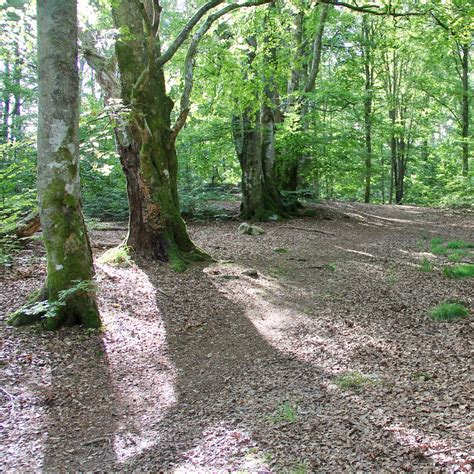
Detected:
[98,264,177,463]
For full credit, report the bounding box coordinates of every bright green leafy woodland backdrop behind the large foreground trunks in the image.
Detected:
[0,0,473,235]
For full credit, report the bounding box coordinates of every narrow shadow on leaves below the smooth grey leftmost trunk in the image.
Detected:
[41,329,117,472]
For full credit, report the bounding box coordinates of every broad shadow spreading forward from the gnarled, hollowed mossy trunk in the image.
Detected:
[115,267,448,472]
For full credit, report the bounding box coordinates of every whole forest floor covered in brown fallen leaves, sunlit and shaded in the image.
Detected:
[0,203,474,473]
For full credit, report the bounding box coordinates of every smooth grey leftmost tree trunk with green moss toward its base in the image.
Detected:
[10,0,101,329]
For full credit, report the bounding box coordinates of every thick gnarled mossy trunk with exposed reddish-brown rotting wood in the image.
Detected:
[113,0,207,270]
